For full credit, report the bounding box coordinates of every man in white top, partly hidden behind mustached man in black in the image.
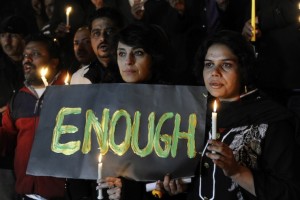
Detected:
[70,26,96,84]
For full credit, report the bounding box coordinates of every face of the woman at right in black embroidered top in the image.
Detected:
[203,44,240,101]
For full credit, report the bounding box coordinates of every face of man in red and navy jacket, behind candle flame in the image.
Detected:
[23,41,58,86]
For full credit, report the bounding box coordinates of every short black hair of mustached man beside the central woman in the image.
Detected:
[89,7,125,30]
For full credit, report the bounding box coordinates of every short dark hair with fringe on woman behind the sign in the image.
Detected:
[116,23,170,82]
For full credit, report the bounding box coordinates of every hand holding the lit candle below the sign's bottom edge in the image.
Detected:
[96,177,122,200]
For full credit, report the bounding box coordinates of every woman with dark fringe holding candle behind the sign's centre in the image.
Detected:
[98,24,189,200]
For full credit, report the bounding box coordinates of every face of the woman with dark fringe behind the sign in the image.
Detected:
[117,42,152,83]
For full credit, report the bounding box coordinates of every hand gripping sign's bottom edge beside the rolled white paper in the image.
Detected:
[156,174,187,196]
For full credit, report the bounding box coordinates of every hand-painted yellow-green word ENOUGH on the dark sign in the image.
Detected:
[51,107,197,158]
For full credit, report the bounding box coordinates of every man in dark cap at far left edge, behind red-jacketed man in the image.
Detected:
[0,16,27,200]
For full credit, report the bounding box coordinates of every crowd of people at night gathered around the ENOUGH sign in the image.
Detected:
[0,0,300,200]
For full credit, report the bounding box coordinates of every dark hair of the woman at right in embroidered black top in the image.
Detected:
[194,30,256,89]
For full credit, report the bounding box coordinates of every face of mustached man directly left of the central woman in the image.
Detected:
[91,17,117,61]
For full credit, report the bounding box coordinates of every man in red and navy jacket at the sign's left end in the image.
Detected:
[0,35,65,200]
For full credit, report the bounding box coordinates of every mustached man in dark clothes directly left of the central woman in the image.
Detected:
[84,7,124,83]
